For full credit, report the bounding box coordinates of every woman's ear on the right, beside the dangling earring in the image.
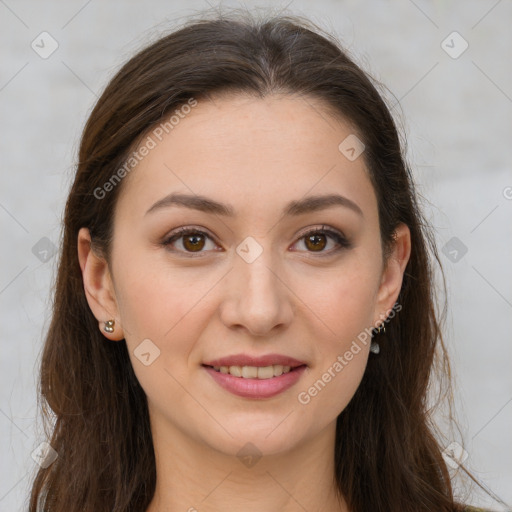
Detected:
[373,223,411,326]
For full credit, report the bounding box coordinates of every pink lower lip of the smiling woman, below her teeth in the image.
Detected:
[203,365,306,399]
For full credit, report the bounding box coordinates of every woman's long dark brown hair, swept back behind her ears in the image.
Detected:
[29,8,468,512]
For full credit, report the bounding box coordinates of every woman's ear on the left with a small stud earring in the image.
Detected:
[78,228,124,341]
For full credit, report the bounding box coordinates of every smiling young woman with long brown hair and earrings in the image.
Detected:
[30,9,492,512]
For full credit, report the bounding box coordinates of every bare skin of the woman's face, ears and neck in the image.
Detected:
[78,95,410,512]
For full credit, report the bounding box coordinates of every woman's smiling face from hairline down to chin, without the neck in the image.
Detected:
[78,95,408,455]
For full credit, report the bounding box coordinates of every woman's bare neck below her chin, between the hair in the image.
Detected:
[146,416,348,512]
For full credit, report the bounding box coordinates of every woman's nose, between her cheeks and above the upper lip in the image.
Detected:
[220,250,295,336]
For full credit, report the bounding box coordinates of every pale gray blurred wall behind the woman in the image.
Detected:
[0,0,512,511]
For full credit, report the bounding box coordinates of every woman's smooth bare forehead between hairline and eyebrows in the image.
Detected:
[114,94,376,222]
